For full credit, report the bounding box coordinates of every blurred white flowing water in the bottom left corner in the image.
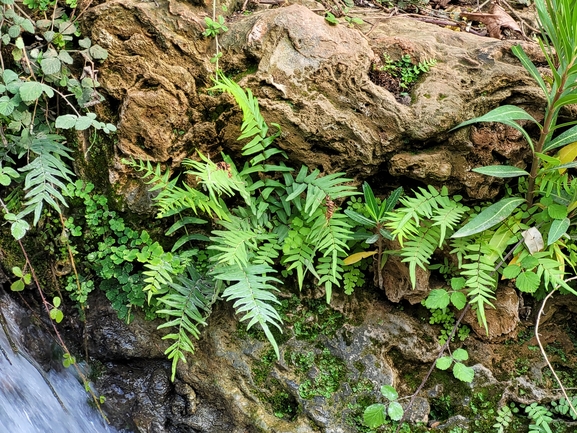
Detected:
[0,289,117,433]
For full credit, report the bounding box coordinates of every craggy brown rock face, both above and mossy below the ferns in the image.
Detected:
[71,0,572,433]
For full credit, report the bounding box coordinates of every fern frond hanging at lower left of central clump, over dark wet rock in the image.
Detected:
[156,266,217,381]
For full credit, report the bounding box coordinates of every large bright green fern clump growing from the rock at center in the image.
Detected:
[129,75,355,366]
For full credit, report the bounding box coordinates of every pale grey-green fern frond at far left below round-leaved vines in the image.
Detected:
[18,133,74,225]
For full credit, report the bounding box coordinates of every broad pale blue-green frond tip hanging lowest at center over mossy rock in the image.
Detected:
[212,264,282,358]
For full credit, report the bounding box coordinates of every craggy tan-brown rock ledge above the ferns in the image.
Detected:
[87,0,542,210]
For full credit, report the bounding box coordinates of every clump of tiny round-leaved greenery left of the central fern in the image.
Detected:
[63,180,185,320]
